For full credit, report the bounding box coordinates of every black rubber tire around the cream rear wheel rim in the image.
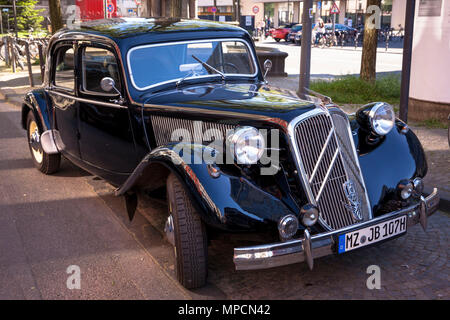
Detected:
[27,111,61,174]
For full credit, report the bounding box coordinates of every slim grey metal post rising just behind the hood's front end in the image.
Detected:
[297,0,313,98]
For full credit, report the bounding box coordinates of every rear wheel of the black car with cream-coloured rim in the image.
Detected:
[27,111,61,174]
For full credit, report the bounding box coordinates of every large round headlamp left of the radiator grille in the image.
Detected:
[228,127,265,164]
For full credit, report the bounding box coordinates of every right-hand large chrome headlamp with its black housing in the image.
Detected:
[357,102,395,136]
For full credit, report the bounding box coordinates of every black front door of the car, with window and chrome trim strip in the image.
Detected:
[78,44,137,173]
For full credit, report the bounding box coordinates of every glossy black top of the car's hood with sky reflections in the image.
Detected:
[138,83,316,122]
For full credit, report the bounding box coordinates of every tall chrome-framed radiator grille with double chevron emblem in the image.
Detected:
[294,112,371,229]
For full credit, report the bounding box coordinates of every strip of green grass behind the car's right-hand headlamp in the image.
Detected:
[311,75,401,104]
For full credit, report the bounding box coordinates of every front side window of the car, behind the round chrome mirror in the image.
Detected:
[81,47,121,95]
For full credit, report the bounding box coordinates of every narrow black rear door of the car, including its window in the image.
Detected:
[47,42,80,158]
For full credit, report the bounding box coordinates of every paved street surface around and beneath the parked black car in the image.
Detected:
[0,97,450,299]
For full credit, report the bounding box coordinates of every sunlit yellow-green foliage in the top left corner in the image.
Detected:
[0,0,44,30]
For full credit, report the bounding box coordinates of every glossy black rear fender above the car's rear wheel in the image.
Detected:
[21,88,52,132]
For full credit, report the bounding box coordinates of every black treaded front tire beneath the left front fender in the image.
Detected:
[167,173,208,289]
